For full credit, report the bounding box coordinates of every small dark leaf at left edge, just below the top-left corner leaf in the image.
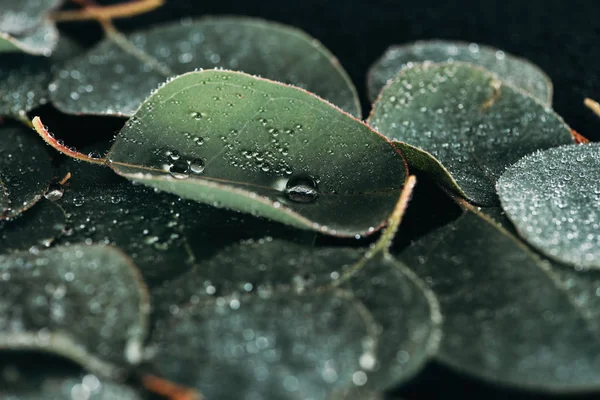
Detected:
[0,36,80,117]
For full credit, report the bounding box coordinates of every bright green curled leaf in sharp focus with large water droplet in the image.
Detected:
[107,70,406,236]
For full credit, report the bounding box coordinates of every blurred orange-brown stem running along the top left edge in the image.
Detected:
[50,0,165,22]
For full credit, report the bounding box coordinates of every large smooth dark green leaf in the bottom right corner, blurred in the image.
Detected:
[399,211,600,392]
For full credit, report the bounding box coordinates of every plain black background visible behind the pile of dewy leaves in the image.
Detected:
[55,0,600,399]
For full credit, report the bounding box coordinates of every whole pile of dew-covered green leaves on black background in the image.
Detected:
[0,0,600,400]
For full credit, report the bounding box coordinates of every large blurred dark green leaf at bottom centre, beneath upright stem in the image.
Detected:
[151,240,439,399]
